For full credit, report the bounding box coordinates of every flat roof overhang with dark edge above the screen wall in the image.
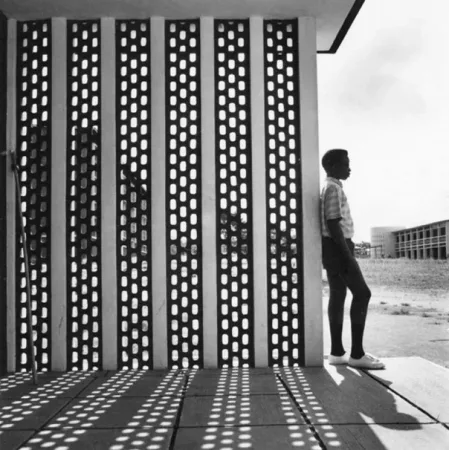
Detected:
[0,0,365,53]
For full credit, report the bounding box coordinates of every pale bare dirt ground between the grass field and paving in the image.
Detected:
[323,285,449,368]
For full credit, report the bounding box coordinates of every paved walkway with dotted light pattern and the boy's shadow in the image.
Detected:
[0,357,449,450]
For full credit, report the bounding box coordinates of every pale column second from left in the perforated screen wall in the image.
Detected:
[50,18,67,371]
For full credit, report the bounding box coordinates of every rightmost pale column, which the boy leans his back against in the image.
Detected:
[298,17,323,366]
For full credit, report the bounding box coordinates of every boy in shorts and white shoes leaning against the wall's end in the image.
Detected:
[321,149,385,369]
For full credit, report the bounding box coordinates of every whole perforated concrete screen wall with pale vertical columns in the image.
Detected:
[2,17,323,371]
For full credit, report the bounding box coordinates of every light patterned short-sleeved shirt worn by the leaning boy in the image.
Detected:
[321,177,354,239]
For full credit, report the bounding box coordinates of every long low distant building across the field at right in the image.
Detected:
[371,220,449,259]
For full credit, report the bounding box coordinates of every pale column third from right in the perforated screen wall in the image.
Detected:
[201,17,218,368]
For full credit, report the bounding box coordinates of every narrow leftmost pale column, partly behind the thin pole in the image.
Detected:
[6,19,17,372]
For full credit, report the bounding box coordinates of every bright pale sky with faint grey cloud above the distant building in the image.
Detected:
[318,0,449,242]
